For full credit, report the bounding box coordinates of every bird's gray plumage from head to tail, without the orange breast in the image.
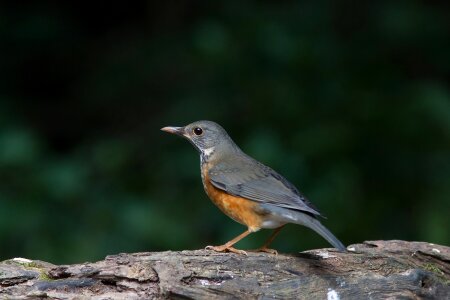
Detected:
[162,121,346,251]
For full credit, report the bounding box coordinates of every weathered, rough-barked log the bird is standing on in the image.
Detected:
[0,241,450,299]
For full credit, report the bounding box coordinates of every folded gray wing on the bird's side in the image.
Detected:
[208,157,320,216]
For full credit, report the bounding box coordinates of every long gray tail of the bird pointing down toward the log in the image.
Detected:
[262,205,347,252]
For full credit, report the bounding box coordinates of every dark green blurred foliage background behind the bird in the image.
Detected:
[0,0,450,263]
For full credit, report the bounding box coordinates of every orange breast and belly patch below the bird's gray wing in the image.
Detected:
[202,168,263,231]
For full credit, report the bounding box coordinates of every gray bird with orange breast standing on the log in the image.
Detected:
[161,120,346,255]
